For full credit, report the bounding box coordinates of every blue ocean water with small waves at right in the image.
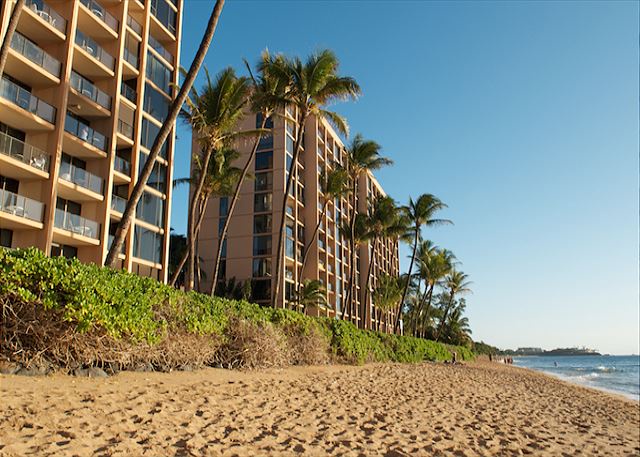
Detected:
[513,355,640,401]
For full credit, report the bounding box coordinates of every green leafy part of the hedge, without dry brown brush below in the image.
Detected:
[0,248,473,363]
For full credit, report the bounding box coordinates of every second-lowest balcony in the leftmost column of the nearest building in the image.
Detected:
[0,133,50,179]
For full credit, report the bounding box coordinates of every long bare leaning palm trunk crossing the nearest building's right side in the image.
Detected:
[104,0,225,268]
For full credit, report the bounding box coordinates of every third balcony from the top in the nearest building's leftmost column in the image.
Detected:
[0,78,56,131]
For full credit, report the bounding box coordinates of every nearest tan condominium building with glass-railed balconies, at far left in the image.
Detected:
[0,0,182,280]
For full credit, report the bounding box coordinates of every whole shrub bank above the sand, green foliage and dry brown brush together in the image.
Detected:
[0,249,473,371]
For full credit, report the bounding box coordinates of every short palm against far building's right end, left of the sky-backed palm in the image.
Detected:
[362,196,406,323]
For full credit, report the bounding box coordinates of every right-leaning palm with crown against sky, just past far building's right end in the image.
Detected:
[394,194,453,332]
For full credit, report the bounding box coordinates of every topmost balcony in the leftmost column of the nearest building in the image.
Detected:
[19,0,67,42]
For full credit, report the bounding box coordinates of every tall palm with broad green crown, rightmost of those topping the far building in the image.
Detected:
[265,50,360,306]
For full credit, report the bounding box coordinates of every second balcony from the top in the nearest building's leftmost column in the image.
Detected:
[5,32,61,87]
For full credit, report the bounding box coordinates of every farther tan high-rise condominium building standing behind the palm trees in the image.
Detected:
[193,110,399,329]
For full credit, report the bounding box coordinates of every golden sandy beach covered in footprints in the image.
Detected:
[0,362,640,456]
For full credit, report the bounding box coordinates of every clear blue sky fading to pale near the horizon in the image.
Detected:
[172,0,640,354]
